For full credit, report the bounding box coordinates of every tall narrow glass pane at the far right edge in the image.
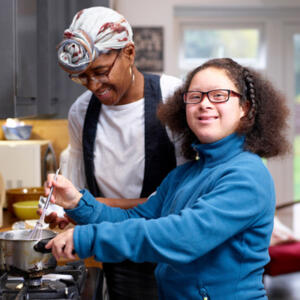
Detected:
[294,34,300,200]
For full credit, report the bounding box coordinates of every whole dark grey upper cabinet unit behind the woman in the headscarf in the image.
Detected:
[0,0,109,119]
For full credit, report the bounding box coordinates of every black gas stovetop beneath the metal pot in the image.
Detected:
[0,261,87,300]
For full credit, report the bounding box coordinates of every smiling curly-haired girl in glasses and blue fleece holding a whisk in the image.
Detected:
[46,59,288,300]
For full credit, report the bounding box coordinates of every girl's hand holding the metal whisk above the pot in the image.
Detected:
[44,174,82,209]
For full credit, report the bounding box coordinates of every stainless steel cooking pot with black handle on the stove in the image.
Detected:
[0,229,56,278]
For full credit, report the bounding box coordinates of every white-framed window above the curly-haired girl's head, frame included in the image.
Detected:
[180,24,264,71]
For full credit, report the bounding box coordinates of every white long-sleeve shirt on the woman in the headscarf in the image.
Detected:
[62,75,183,198]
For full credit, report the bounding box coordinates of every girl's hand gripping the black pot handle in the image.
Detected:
[45,228,76,260]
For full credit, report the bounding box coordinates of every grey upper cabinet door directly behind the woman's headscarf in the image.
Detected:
[37,0,109,118]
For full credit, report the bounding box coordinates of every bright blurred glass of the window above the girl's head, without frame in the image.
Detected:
[183,28,260,59]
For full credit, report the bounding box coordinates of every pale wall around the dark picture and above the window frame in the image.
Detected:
[112,0,300,76]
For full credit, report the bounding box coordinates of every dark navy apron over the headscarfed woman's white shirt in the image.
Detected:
[82,74,176,300]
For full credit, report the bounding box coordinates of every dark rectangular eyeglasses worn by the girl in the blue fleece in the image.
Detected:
[183,89,242,104]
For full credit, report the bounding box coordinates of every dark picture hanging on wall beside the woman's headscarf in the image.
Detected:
[133,27,164,73]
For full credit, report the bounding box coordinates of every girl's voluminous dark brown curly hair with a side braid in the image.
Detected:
[157,58,290,159]
